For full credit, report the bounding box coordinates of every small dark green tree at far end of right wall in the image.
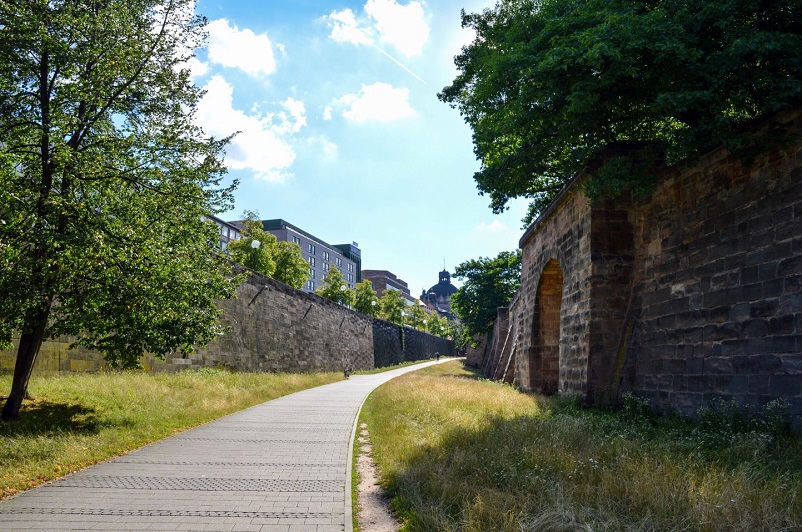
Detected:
[451,250,521,343]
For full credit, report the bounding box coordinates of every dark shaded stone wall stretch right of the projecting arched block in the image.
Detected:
[622,114,802,419]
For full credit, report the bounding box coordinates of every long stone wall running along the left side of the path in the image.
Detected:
[0,275,454,375]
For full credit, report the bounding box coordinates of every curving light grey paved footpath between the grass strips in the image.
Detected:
[0,362,446,532]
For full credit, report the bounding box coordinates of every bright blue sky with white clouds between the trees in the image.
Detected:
[191,0,526,297]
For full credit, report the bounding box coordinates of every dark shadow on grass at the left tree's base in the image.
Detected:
[0,400,107,437]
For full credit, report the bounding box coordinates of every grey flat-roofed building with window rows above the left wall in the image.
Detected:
[262,218,362,292]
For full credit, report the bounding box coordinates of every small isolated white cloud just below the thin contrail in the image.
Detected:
[336,82,417,124]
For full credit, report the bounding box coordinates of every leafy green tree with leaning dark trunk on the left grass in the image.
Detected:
[0,0,239,419]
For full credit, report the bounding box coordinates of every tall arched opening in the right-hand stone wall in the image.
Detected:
[529,259,563,395]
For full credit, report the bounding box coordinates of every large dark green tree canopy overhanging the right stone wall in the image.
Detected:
[438,0,802,223]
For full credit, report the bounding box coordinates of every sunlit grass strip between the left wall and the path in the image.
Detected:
[0,370,342,497]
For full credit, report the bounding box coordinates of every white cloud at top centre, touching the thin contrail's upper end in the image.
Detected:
[324,0,429,57]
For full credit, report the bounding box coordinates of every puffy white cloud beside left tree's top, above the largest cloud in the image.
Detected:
[206,18,282,76]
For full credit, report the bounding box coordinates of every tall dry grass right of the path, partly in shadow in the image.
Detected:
[362,362,802,531]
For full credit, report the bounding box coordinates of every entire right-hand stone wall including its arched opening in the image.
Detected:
[476,112,802,426]
